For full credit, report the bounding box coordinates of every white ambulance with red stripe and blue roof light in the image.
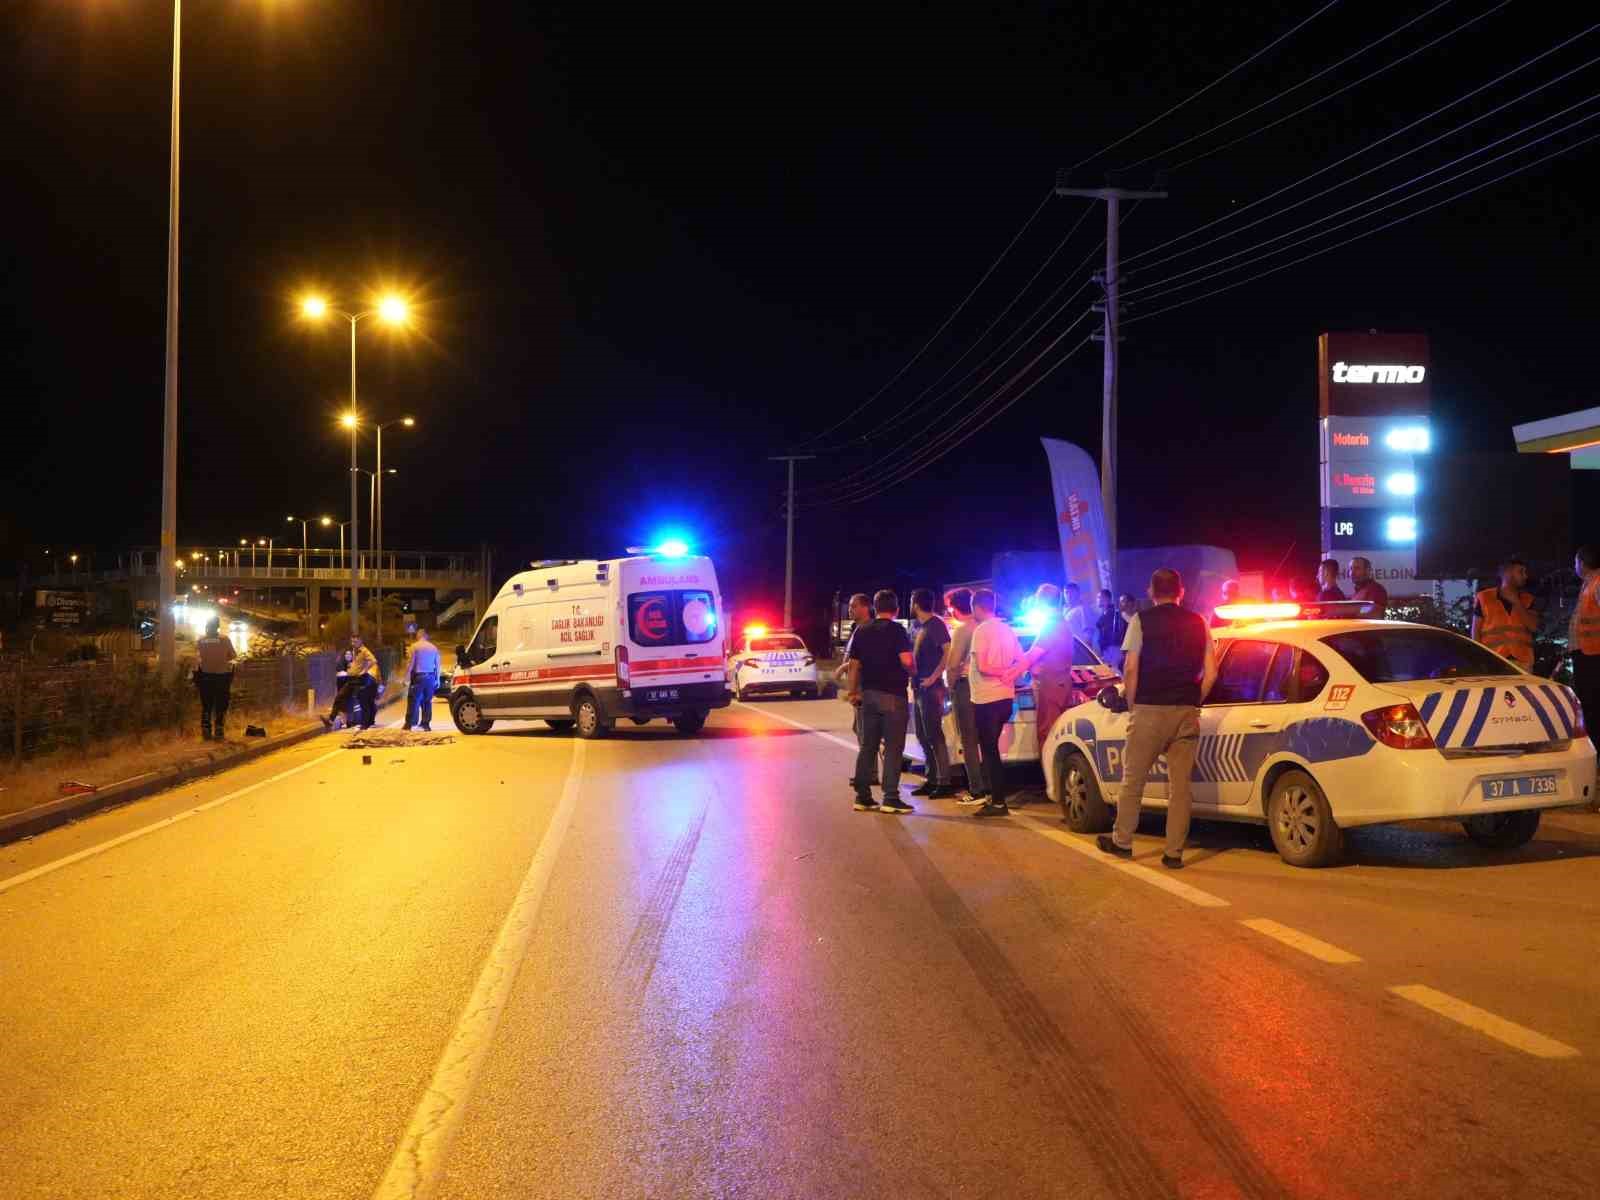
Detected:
[450,555,731,738]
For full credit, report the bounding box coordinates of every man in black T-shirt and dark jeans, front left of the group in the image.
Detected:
[850,589,917,814]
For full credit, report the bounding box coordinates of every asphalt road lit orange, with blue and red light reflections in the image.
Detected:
[0,701,1600,1200]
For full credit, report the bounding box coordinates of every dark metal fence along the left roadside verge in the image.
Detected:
[0,653,353,760]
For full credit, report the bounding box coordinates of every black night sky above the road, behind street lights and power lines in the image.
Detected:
[0,0,1600,633]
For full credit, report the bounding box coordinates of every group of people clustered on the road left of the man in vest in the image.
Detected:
[840,584,1138,818]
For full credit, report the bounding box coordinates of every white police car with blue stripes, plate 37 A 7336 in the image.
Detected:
[1043,603,1595,867]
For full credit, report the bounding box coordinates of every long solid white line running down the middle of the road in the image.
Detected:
[373,738,586,1200]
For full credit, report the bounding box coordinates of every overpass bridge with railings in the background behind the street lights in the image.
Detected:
[29,546,490,634]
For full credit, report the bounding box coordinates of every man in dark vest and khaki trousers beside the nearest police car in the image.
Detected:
[1098,566,1216,870]
